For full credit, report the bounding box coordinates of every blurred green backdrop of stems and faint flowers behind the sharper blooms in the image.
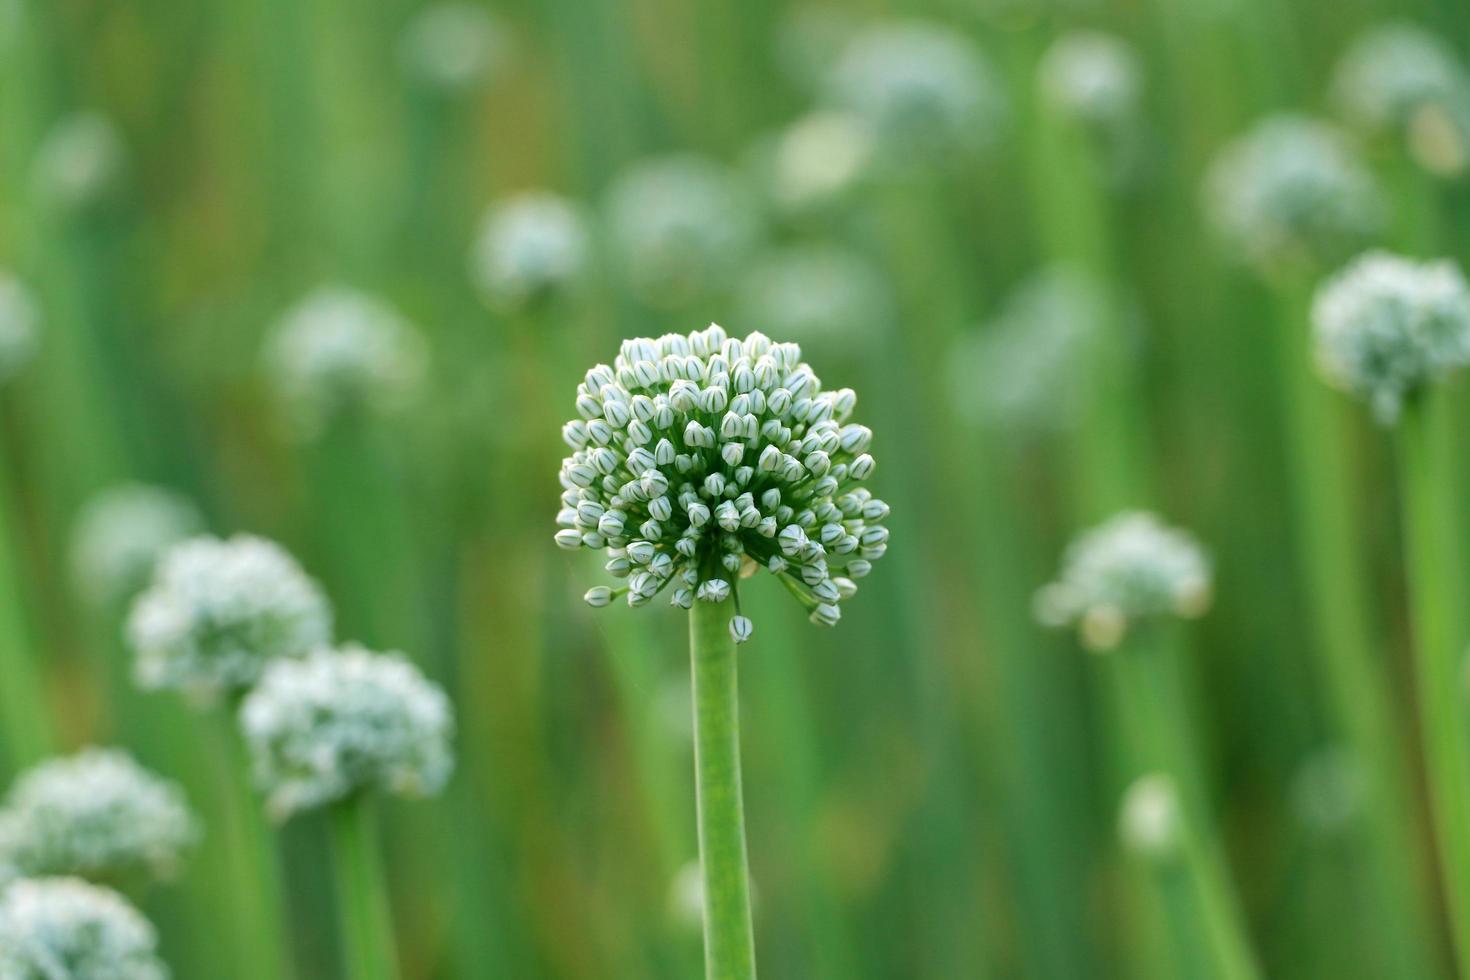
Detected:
[0,0,1470,980]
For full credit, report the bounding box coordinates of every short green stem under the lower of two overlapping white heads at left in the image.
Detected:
[331,796,398,980]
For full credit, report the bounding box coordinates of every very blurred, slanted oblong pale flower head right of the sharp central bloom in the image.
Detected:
[950,266,1107,436]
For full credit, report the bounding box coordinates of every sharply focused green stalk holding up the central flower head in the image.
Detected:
[689,599,756,980]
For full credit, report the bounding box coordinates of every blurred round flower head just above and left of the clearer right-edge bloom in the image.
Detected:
[1205,116,1380,270]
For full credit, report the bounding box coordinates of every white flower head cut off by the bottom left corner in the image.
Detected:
[0,877,169,980]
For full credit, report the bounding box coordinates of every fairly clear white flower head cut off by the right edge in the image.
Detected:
[1311,251,1470,423]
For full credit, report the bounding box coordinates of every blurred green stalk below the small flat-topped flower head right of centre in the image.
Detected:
[1110,627,1260,980]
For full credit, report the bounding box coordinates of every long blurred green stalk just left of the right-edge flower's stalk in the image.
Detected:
[1276,282,1435,977]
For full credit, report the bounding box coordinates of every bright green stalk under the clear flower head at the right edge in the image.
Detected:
[1398,388,1470,977]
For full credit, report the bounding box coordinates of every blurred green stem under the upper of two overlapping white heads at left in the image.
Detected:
[210,710,294,980]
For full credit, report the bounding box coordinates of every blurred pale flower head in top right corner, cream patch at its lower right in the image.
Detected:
[1332,22,1470,175]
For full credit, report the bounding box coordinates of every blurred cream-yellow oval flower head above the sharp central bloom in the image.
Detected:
[763,112,873,215]
